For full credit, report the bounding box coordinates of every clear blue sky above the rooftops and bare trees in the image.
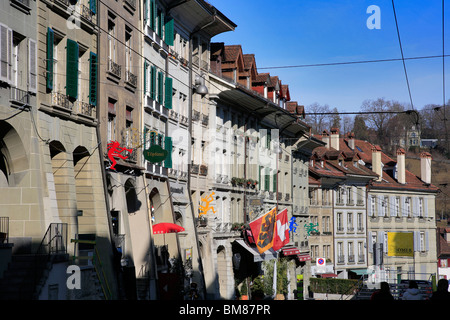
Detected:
[210,0,450,112]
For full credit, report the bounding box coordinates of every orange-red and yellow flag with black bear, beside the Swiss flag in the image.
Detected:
[249,208,277,253]
